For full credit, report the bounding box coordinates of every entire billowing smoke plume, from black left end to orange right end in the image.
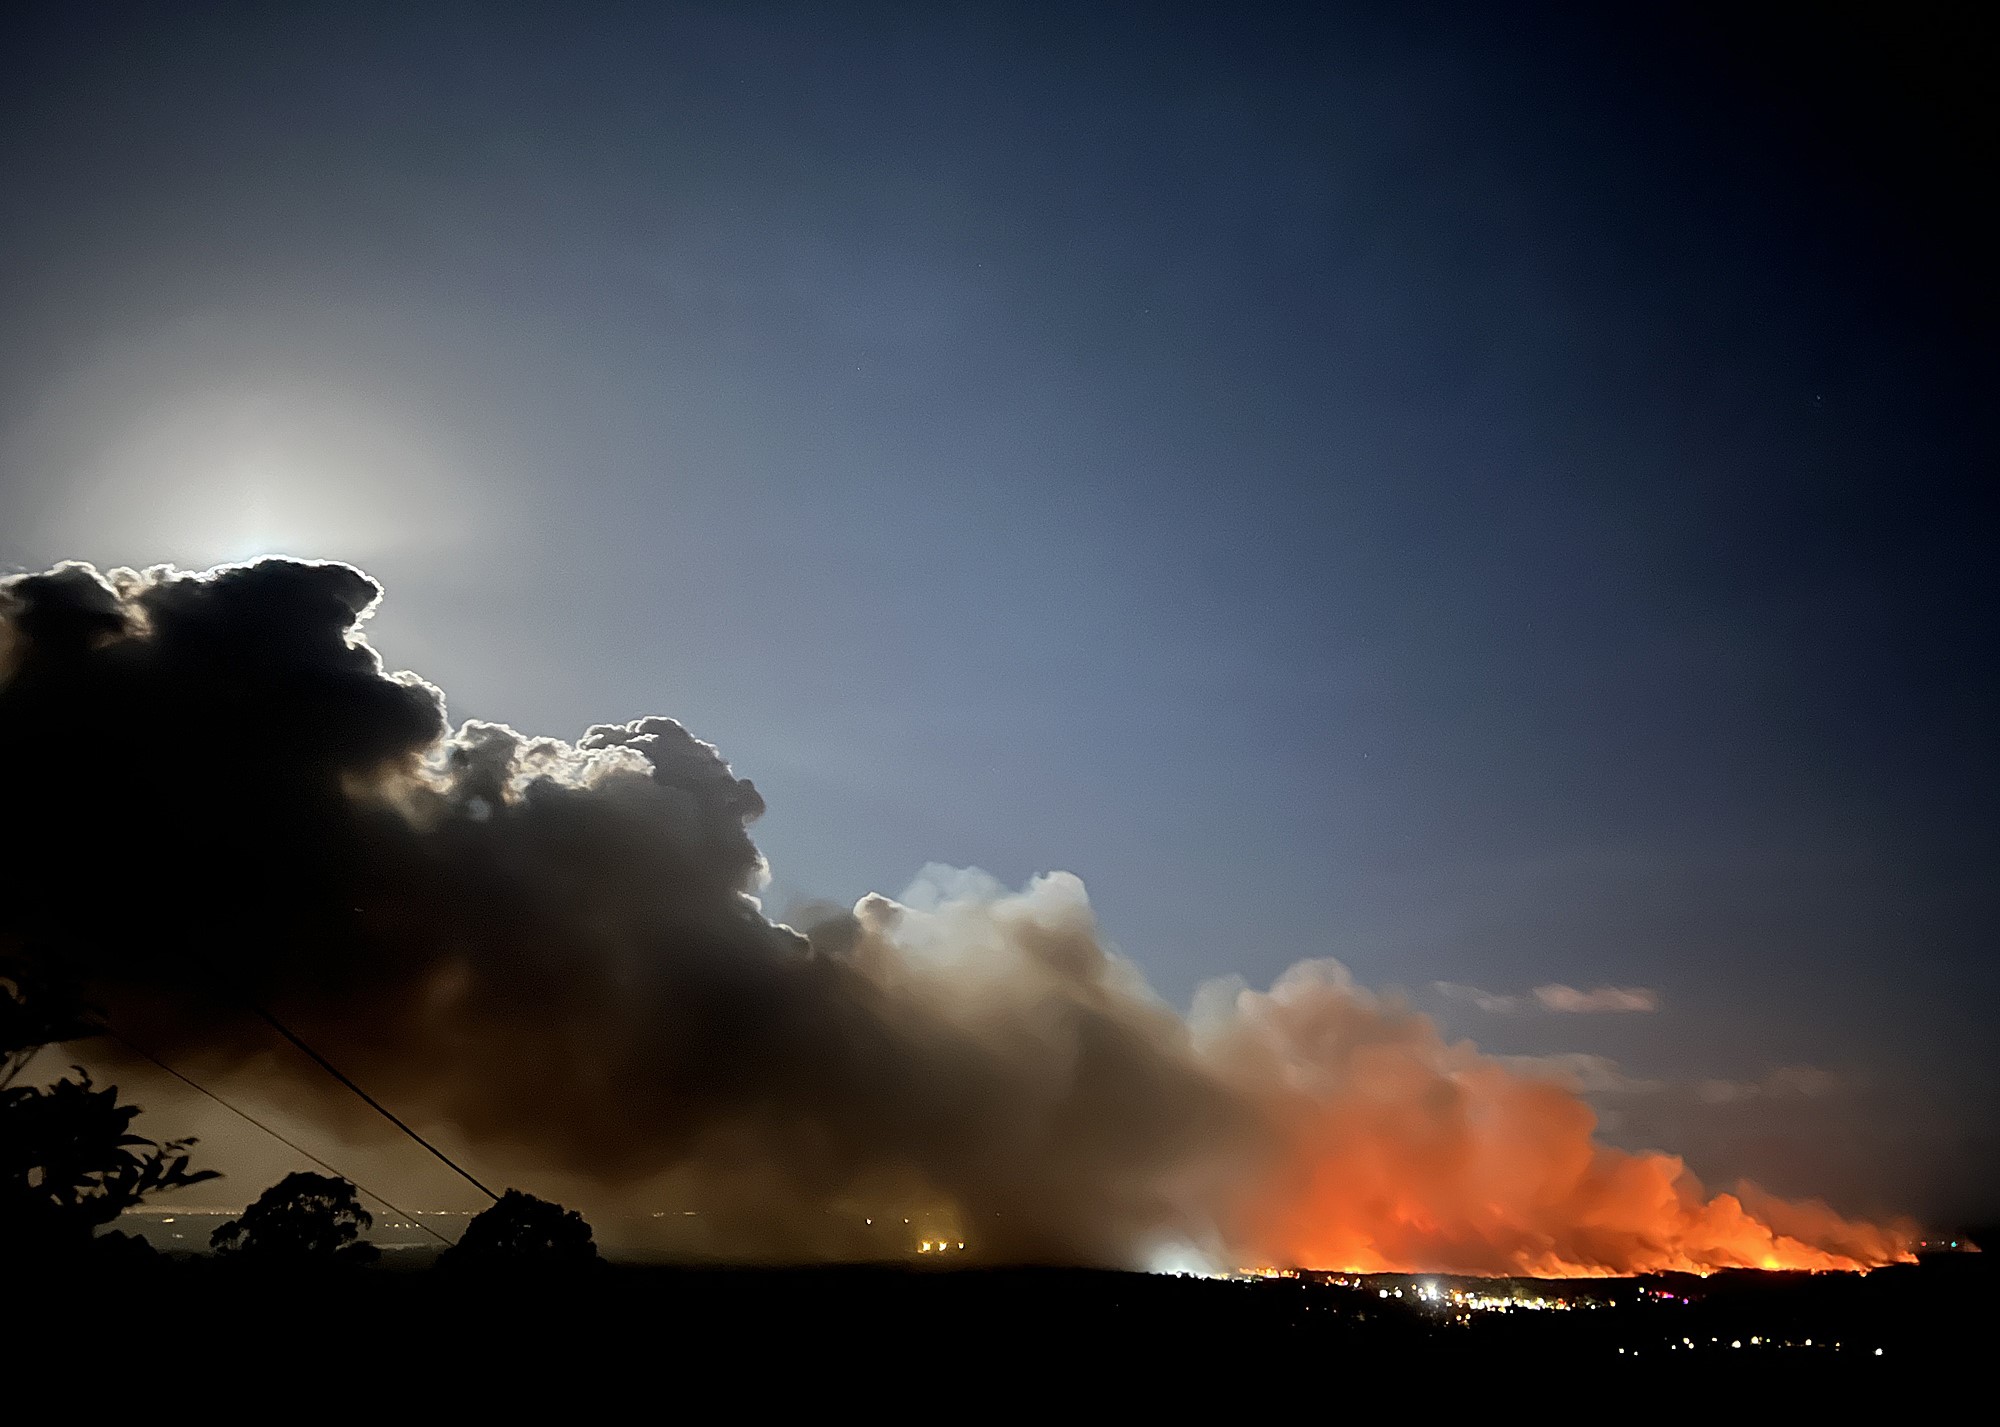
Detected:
[0,560,1904,1271]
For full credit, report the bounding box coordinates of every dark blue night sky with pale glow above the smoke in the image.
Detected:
[0,4,2000,1213]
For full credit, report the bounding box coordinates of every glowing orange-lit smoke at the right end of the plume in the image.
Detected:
[1198,961,1914,1277]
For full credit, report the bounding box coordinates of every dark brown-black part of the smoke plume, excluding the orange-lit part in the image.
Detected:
[0,560,1232,1259]
